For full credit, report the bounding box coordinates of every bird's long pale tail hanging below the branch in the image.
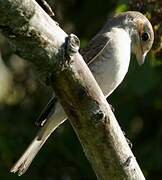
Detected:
[10,103,66,176]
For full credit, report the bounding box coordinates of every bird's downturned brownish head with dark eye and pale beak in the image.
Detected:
[126,11,154,65]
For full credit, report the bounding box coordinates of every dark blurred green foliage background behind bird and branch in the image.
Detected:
[0,0,162,180]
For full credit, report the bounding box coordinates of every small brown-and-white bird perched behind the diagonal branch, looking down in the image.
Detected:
[10,11,154,175]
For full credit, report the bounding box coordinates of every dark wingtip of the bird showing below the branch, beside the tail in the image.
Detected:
[35,96,57,126]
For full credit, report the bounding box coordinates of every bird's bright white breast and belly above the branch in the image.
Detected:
[90,28,131,96]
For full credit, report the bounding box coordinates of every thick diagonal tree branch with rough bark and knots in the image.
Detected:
[0,0,145,180]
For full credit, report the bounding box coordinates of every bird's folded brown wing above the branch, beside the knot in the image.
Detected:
[80,34,110,64]
